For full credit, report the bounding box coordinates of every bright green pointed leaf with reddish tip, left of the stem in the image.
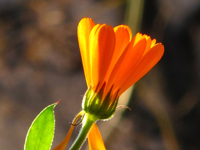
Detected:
[24,101,59,150]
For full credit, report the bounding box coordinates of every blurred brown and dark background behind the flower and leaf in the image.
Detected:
[0,0,200,150]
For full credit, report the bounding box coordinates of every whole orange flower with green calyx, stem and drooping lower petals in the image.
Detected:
[55,18,164,150]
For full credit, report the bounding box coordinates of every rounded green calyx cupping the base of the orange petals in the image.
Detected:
[82,85,118,120]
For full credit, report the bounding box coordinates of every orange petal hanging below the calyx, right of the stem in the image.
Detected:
[88,123,106,150]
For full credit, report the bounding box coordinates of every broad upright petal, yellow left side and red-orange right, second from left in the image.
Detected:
[89,24,115,88]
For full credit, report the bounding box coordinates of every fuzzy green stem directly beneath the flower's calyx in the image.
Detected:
[69,114,97,150]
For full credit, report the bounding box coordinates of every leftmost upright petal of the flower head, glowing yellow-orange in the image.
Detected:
[77,18,95,87]
